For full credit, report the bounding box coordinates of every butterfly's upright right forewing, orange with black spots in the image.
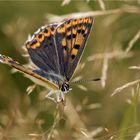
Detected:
[55,17,93,80]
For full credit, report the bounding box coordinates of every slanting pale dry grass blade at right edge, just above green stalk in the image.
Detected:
[111,79,140,96]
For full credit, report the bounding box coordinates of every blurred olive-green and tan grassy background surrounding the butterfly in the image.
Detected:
[0,0,140,140]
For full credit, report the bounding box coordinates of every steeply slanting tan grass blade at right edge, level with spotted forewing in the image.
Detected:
[125,30,140,53]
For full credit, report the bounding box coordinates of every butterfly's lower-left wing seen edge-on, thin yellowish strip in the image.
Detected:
[0,54,59,90]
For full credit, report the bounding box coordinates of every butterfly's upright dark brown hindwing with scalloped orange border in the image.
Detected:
[26,24,61,75]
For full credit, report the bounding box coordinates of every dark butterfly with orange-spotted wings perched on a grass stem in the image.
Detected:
[0,17,94,102]
